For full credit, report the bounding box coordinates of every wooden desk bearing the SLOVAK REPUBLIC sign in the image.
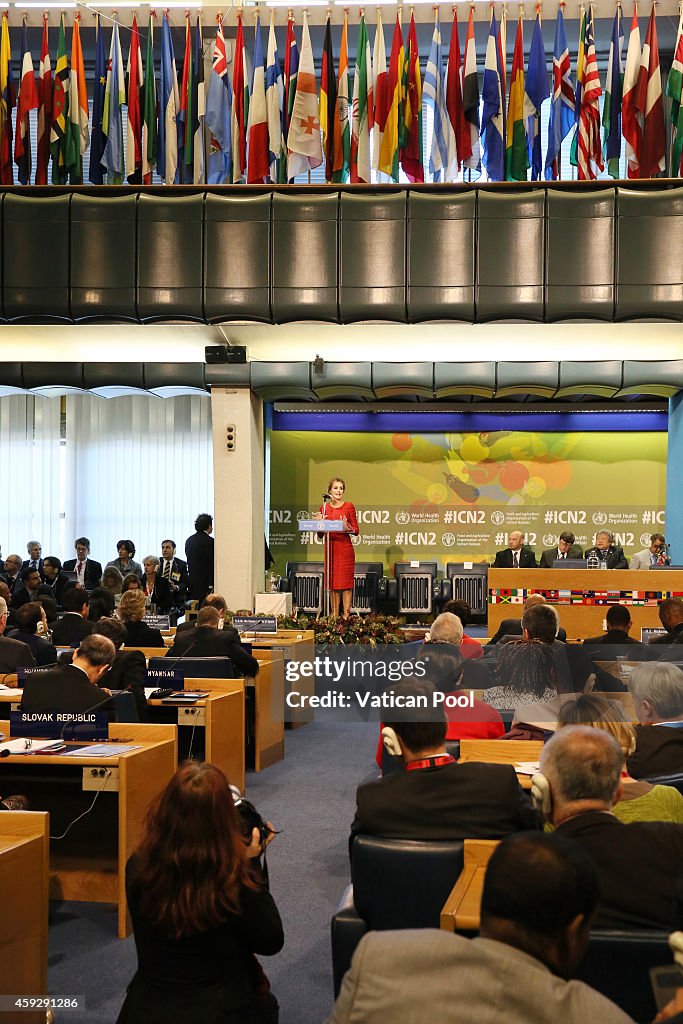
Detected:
[0,721,177,939]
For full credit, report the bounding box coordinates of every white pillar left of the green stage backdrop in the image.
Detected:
[211,387,264,611]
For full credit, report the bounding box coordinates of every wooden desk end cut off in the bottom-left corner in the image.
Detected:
[0,811,49,1024]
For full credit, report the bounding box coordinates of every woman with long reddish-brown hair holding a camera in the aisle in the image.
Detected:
[118,761,284,1024]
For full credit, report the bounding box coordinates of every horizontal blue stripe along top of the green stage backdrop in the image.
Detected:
[266,407,668,434]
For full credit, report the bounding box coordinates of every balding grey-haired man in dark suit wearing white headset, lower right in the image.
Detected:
[532,725,683,931]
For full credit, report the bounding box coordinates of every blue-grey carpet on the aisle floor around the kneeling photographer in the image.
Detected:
[49,723,377,1024]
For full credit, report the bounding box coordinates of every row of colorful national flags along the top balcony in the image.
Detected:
[0,3,683,185]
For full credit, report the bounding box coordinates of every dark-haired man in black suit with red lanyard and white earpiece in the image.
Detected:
[351,679,539,840]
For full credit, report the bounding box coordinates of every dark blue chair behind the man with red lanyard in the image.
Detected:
[332,836,464,997]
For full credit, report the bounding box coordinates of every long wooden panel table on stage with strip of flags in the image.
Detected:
[488,568,683,638]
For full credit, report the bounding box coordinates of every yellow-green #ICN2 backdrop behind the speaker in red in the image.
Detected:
[269,416,667,574]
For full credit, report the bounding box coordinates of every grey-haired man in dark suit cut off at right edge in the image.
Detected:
[629,662,683,778]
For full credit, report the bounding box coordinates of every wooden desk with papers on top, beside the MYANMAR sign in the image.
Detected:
[147,679,245,793]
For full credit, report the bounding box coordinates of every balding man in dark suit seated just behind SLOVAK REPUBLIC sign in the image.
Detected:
[22,634,116,712]
